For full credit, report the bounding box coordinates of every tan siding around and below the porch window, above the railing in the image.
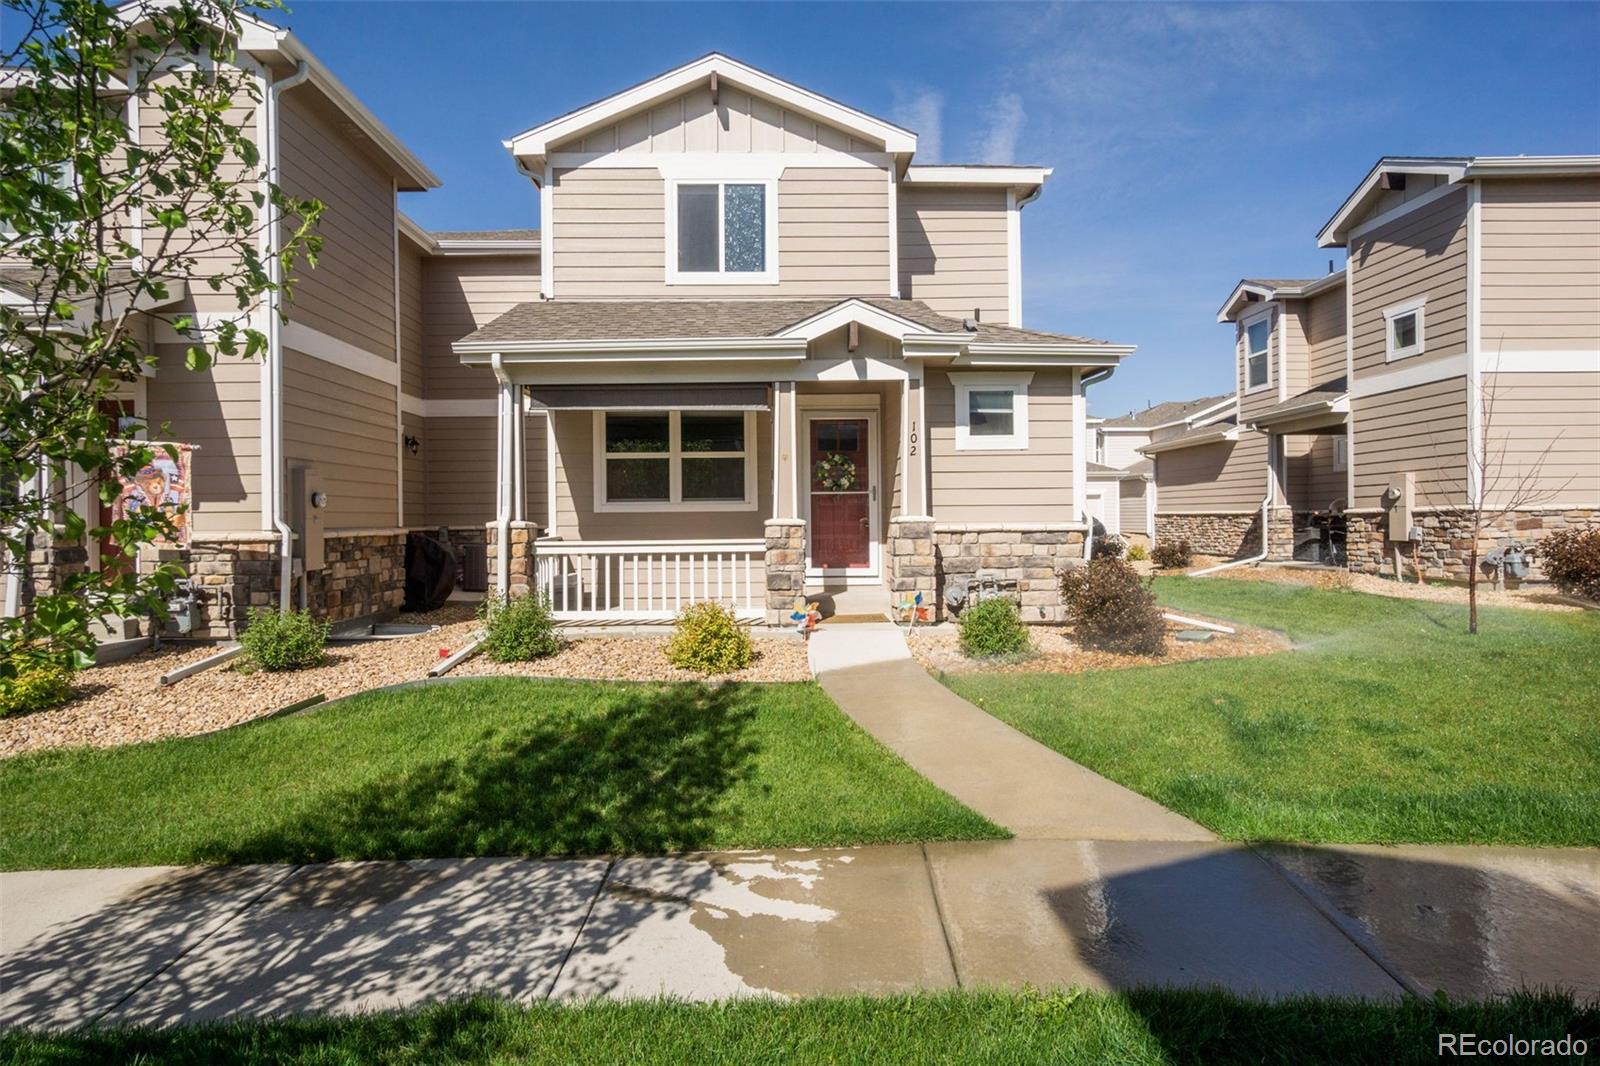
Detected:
[555,411,773,541]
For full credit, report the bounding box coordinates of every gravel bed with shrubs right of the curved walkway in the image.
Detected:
[909,614,1291,674]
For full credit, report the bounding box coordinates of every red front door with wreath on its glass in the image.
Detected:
[810,418,872,570]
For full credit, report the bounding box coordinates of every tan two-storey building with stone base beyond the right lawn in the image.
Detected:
[1142,157,1600,576]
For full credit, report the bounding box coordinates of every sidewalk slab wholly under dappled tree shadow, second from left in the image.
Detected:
[107,860,606,1024]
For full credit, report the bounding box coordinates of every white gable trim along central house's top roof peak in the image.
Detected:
[504,53,917,157]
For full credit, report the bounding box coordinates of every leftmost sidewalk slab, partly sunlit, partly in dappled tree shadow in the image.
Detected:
[0,866,293,1029]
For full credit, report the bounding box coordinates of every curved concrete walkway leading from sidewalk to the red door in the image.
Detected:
[810,624,1216,840]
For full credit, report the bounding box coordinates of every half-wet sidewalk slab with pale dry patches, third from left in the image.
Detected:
[555,845,955,999]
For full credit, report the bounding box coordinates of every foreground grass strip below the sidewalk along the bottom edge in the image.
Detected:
[0,991,1600,1066]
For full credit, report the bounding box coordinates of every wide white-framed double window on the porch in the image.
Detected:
[595,411,757,511]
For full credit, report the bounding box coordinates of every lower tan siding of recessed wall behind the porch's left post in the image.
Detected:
[422,415,549,525]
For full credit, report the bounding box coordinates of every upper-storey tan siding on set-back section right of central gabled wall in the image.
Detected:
[896,186,1011,325]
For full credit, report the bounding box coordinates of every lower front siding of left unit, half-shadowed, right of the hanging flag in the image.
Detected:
[146,344,261,533]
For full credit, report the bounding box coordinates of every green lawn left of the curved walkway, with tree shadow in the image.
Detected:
[0,677,1006,869]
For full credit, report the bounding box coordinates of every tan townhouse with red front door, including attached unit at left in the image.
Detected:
[9,21,1133,635]
